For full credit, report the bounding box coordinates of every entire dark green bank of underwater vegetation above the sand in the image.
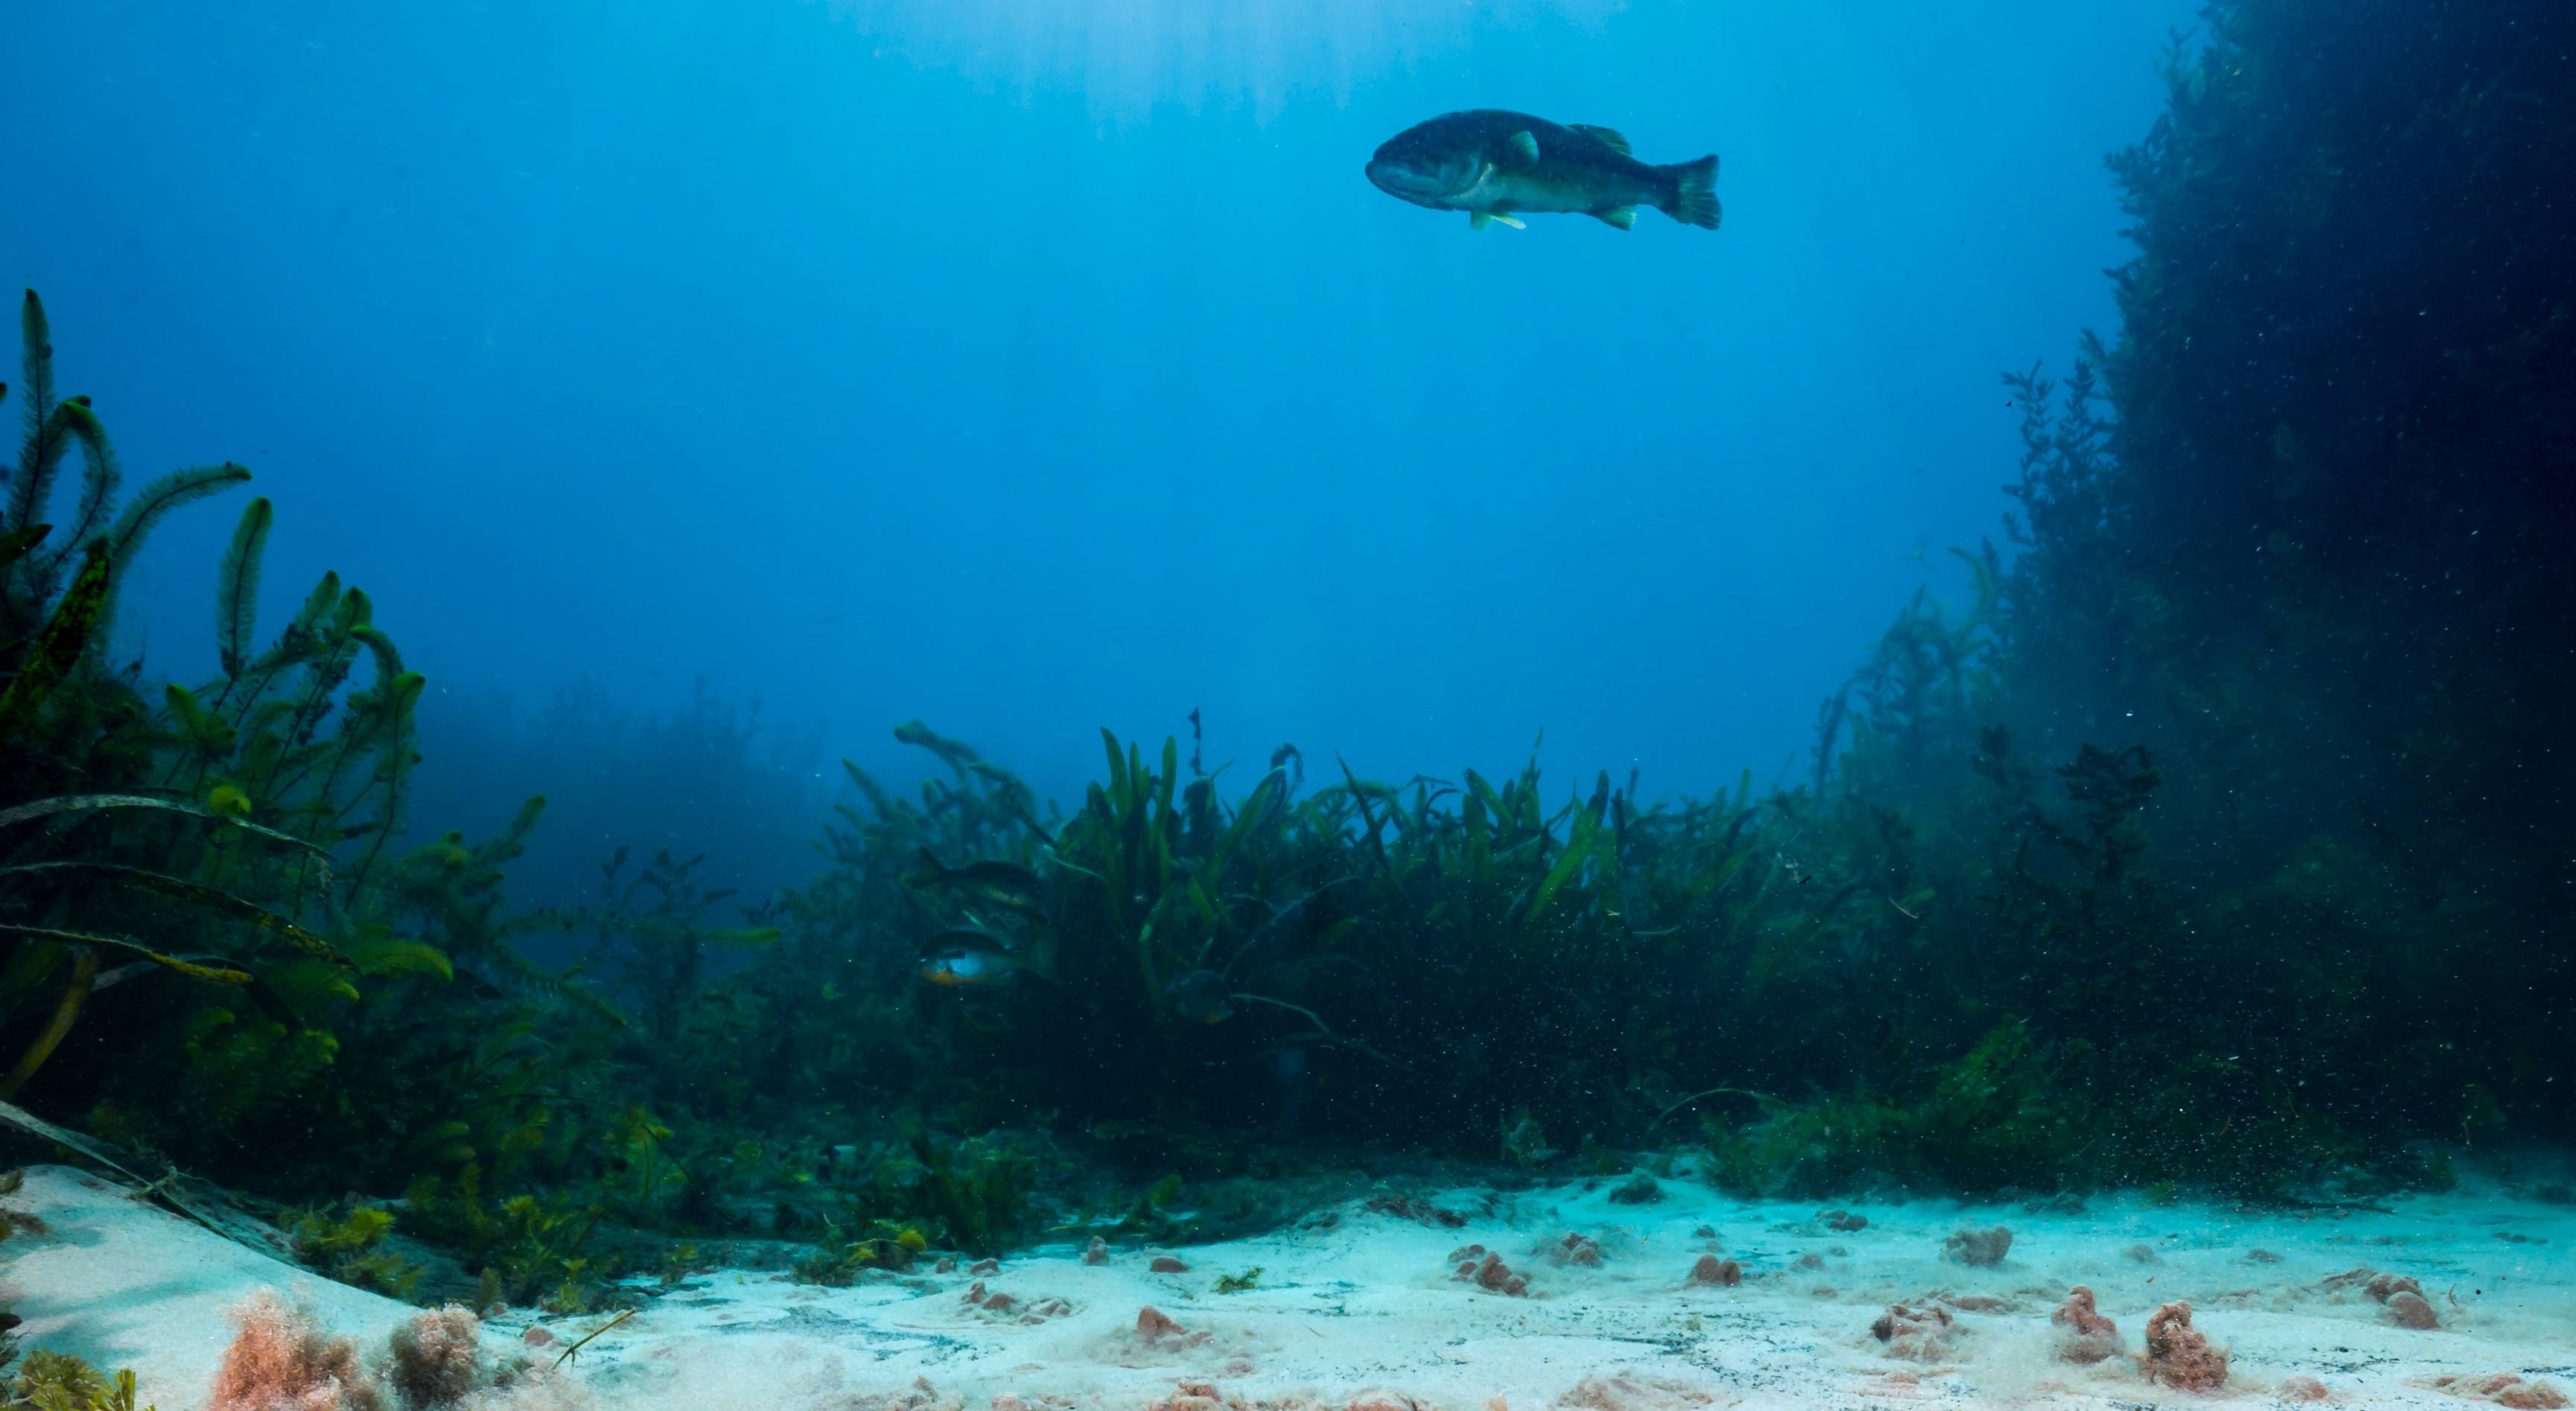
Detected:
[0,0,2576,1308]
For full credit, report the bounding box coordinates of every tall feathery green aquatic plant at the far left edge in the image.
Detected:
[0,293,602,1220]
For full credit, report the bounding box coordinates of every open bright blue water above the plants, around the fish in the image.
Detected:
[0,0,2189,859]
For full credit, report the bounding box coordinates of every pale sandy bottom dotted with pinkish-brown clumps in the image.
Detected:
[0,1166,2576,1411]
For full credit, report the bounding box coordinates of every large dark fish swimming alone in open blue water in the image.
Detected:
[1368,108,1718,229]
